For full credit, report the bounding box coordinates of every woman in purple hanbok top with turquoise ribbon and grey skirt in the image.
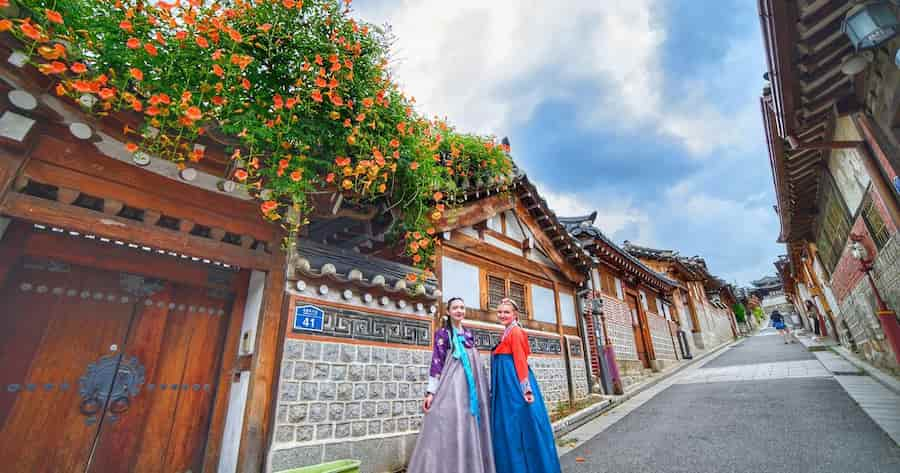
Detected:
[406,297,494,473]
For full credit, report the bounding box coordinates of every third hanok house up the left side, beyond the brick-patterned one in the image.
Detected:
[624,241,737,352]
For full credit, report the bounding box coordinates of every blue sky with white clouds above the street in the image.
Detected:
[353,0,784,285]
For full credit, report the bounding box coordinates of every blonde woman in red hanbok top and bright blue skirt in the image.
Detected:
[491,298,560,473]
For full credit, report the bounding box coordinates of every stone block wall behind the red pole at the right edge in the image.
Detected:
[838,233,900,372]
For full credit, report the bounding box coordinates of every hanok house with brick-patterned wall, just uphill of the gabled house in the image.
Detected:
[560,212,689,394]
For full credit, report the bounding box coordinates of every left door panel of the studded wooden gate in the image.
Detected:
[0,258,134,473]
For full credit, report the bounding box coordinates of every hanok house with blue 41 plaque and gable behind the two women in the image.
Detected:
[269,171,590,471]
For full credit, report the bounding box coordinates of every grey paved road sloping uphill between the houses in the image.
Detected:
[562,335,900,473]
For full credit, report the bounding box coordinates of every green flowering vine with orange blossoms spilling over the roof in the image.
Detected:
[0,0,512,280]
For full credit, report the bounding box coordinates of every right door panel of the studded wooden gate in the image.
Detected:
[90,283,230,473]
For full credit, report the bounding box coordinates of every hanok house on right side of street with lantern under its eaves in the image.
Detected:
[760,0,900,369]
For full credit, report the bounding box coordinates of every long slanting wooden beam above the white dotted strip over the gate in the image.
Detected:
[0,194,272,270]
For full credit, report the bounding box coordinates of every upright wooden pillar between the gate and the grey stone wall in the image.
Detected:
[238,250,285,472]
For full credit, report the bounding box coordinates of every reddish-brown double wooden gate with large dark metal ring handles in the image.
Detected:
[0,227,232,473]
